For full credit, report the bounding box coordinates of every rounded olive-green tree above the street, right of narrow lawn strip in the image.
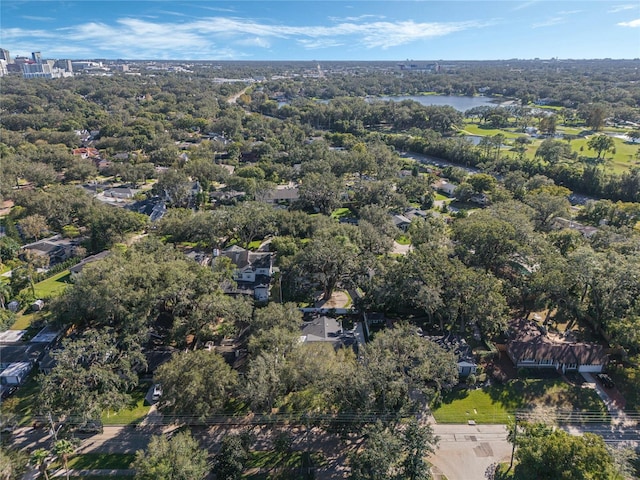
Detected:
[155,350,238,418]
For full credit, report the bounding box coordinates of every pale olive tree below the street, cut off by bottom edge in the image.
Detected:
[131,432,209,480]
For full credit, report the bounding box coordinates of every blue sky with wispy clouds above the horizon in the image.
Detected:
[0,0,640,61]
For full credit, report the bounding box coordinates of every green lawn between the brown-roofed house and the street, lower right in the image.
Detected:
[433,378,606,423]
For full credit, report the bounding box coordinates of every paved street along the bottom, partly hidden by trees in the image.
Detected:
[12,423,640,480]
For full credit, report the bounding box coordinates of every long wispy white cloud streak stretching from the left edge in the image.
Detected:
[0,16,489,58]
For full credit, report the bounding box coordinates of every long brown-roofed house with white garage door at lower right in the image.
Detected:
[507,319,608,373]
